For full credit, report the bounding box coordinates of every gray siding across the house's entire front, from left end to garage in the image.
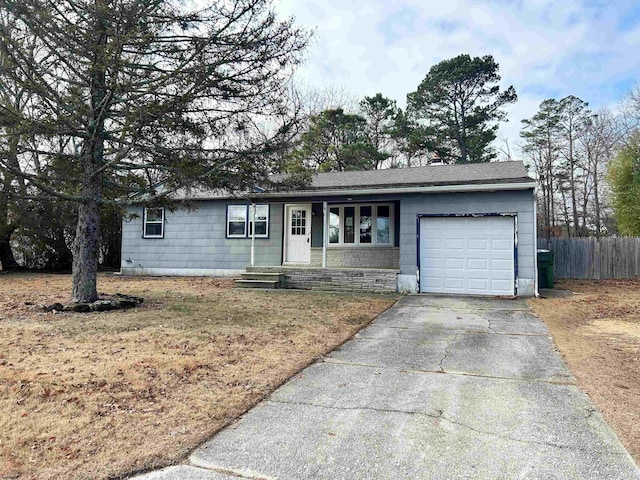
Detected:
[122,189,535,290]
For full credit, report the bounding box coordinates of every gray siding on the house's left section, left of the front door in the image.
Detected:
[122,201,283,270]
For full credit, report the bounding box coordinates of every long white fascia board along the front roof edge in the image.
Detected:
[251,182,536,198]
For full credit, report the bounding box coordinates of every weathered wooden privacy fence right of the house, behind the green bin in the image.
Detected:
[538,237,640,279]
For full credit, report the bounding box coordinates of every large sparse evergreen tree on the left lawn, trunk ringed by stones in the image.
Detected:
[0,0,308,301]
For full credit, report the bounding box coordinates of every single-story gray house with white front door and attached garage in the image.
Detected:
[122,162,537,296]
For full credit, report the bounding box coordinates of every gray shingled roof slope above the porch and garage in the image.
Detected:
[302,162,533,191]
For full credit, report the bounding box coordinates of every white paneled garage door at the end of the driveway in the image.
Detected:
[420,216,515,295]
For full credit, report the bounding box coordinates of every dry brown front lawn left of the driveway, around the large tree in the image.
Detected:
[0,274,395,479]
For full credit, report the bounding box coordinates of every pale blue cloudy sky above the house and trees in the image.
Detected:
[276,0,640,158]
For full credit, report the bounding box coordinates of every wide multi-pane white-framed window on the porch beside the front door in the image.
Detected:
[329,204,393,246]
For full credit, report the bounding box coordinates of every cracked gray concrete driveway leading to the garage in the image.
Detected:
[136,296,640,480]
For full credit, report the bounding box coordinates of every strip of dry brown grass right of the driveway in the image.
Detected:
[529,280,640,464]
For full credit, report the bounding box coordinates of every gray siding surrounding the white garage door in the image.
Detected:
[400,189,535,280]
